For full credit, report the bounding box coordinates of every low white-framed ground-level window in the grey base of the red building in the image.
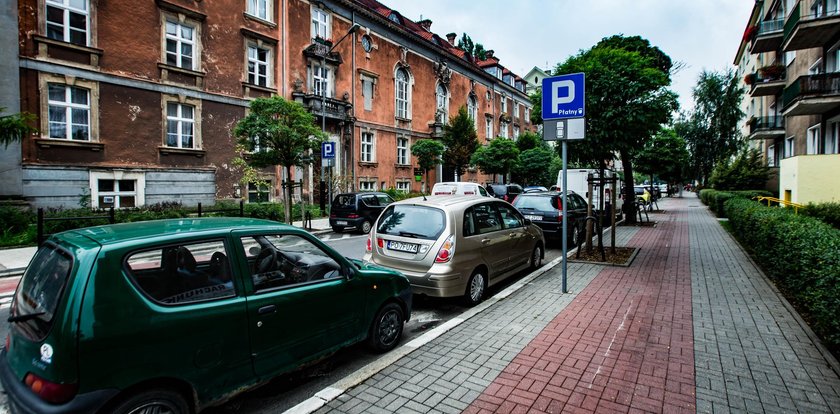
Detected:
[90,171,146,208]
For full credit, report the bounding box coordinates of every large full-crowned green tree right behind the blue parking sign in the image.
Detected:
[552,36,677,222]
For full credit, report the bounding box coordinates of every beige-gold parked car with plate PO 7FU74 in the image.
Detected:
[364,197,545,305]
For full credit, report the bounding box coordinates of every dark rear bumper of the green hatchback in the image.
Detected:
[0,349,119,414]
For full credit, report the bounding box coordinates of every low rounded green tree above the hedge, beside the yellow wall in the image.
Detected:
[709,148,770,191]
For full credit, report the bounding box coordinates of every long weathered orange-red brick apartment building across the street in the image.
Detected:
[0,0,533,208]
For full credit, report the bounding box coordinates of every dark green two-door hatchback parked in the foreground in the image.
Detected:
[0,218,411,413]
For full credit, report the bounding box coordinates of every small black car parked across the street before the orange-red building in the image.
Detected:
[330,192,394,233]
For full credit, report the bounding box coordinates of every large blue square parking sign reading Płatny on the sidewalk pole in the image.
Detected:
[542,73,586,120]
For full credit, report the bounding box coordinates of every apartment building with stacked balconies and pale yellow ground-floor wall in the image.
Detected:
[736,0,840,203]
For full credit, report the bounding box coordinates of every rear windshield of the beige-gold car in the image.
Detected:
[376,204,446,240]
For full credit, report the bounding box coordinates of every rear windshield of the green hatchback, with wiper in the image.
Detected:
[10,244,73,340]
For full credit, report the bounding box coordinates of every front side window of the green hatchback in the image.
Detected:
[241,234,342,292]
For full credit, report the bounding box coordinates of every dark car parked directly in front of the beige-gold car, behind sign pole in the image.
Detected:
[513,191,586,246]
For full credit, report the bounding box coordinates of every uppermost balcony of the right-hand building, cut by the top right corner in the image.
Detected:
[782,1,840,51]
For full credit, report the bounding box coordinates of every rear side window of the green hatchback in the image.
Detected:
[126,240,235,305]
